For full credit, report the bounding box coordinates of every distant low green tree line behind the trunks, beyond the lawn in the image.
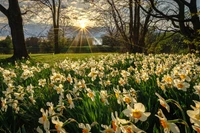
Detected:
[0,32,188,54]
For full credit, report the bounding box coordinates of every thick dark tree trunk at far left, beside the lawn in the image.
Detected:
[0,0,29,59]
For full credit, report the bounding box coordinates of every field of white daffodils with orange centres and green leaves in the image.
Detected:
[0,53,200,133]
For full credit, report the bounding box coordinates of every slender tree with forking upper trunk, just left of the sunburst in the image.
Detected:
[33,0,62,54]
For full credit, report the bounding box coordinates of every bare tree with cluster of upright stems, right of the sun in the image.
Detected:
[93,0,152,53]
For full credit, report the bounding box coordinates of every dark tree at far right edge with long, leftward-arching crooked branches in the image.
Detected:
[141,0,200,52]
